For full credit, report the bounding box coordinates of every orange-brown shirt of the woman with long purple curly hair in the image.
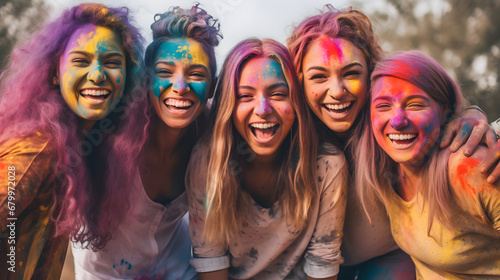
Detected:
[0,132,68,279]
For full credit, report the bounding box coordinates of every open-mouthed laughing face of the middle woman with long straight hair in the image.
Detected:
[233,58,295,159]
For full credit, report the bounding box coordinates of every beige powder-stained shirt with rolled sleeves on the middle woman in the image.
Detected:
[186,145,348,280]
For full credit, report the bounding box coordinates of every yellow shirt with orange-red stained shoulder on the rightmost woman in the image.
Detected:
[388,148,500,280]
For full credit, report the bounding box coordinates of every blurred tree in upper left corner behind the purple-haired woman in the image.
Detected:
[0,0,48,71]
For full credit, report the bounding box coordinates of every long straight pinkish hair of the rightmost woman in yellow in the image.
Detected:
[355,51,469,231]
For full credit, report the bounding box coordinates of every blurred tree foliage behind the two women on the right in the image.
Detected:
[360,0,500,121]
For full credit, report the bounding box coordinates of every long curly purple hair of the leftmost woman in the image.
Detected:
[0,4,143,248]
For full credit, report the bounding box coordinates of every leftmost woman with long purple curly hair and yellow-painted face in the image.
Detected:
[0,4,142,279]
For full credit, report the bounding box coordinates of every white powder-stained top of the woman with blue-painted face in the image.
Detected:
[72,169,198,280]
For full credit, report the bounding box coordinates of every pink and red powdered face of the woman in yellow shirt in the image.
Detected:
[370,76,444,168]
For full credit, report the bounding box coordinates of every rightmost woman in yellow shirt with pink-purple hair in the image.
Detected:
[356,51,500,279]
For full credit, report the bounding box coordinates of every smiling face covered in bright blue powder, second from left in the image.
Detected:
[149,38,211,129]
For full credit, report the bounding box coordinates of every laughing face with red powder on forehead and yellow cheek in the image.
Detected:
[302,35,368,132]
